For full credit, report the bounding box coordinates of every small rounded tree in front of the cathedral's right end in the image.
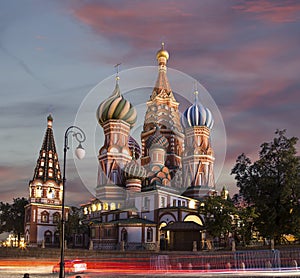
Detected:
[199,196,236,247]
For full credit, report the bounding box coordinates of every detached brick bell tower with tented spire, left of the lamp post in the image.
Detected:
[25,115,69,246]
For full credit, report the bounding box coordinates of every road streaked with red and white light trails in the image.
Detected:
[0,259,300,278]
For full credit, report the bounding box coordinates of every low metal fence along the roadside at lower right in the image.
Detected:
[150,249,300,270]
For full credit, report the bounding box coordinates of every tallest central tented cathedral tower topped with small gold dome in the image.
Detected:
[141,44,184,182]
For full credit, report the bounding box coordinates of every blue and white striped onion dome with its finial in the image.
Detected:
[181,91,214,129]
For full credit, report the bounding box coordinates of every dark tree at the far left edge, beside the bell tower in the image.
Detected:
[0,198,28,245]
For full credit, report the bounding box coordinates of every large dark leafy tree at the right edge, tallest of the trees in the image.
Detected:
[231,130,300,243]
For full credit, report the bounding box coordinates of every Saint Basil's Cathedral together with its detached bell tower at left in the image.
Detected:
[25,45,223,250]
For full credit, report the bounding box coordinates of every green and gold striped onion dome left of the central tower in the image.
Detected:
[96,79,137,128]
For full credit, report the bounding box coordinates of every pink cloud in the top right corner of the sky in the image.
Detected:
[233,0,300,23]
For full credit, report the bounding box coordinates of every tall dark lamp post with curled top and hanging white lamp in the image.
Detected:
[59,126,86,278]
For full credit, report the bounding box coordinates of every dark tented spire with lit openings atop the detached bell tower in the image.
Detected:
[33,115,62,183]
